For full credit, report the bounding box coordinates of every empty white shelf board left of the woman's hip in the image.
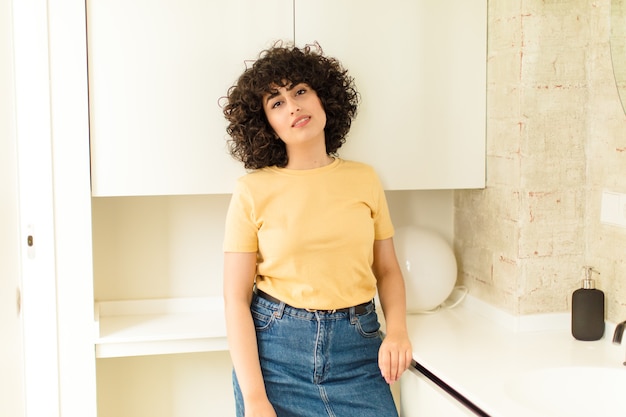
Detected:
[95,297,228,358]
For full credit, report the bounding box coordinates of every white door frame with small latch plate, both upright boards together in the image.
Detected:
[11,0,97,417]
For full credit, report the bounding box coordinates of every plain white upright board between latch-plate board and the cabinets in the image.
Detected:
[48,0,97,417]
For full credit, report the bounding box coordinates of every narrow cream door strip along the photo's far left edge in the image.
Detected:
[0,0,24,417]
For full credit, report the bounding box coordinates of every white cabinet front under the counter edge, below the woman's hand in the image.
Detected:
[400,367,476,417]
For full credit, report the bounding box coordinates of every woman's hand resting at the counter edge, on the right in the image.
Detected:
[378,333,413,384]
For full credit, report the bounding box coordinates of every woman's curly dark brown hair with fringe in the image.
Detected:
[223,43,360,169]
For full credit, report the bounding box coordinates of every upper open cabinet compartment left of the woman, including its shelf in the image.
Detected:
[92,195,229,358]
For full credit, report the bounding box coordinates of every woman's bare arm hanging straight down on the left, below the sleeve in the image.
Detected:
[224,252,276,417]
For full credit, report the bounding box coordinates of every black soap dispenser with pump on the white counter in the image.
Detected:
[572,266,604,341]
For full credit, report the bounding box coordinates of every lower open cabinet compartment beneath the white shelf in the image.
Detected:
[95,352,235,417]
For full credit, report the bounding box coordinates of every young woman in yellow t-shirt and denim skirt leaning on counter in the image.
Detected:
[224,45,412,417]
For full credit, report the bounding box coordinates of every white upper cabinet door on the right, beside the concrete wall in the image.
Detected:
[295,0,487,189]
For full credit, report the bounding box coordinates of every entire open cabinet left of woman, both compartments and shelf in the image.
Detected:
[91,194,239,417]
